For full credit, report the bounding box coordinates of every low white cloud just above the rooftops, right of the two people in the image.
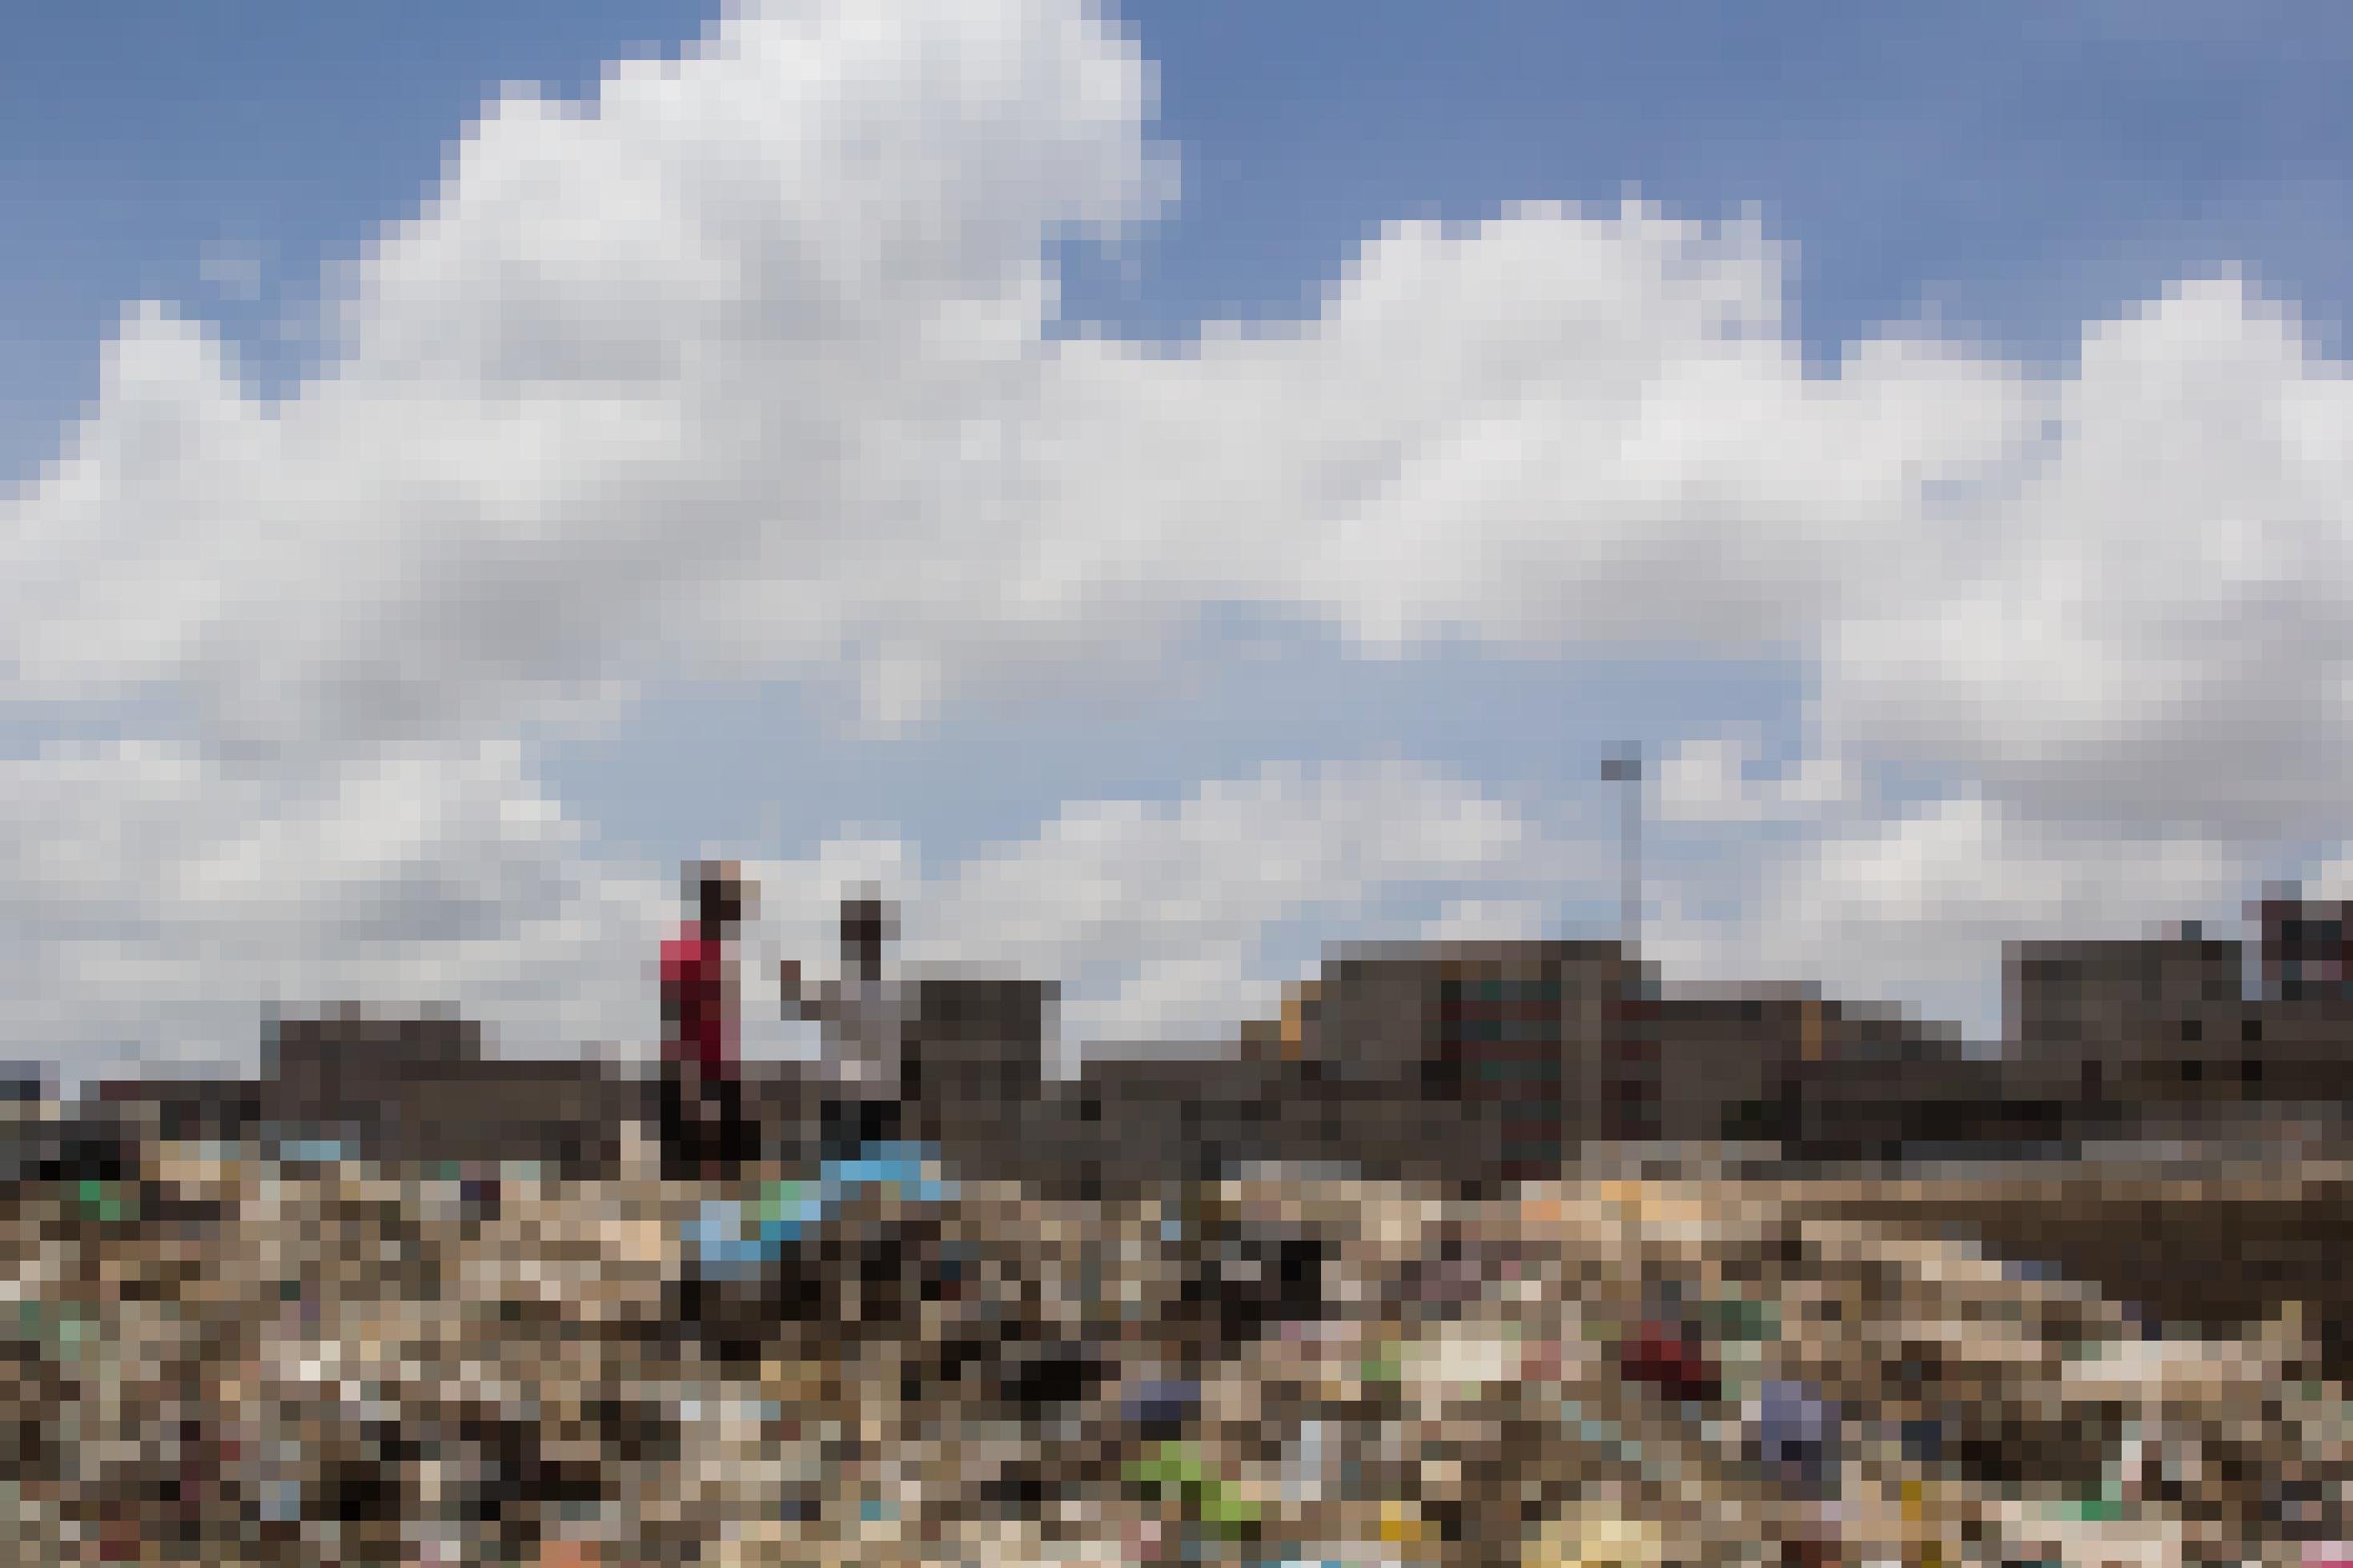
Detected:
[725,764,1600,1067]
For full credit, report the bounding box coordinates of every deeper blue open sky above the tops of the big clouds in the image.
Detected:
[18,0,2353,472]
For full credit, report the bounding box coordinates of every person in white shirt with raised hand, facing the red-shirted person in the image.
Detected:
[779,898,906,1159]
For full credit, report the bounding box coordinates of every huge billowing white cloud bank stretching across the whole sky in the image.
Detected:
[0,0,2353,1081]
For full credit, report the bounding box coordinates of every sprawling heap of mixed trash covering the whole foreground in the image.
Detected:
[0,1123,2353,1568]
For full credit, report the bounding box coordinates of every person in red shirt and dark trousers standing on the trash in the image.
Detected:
[661,860,757,1180]
